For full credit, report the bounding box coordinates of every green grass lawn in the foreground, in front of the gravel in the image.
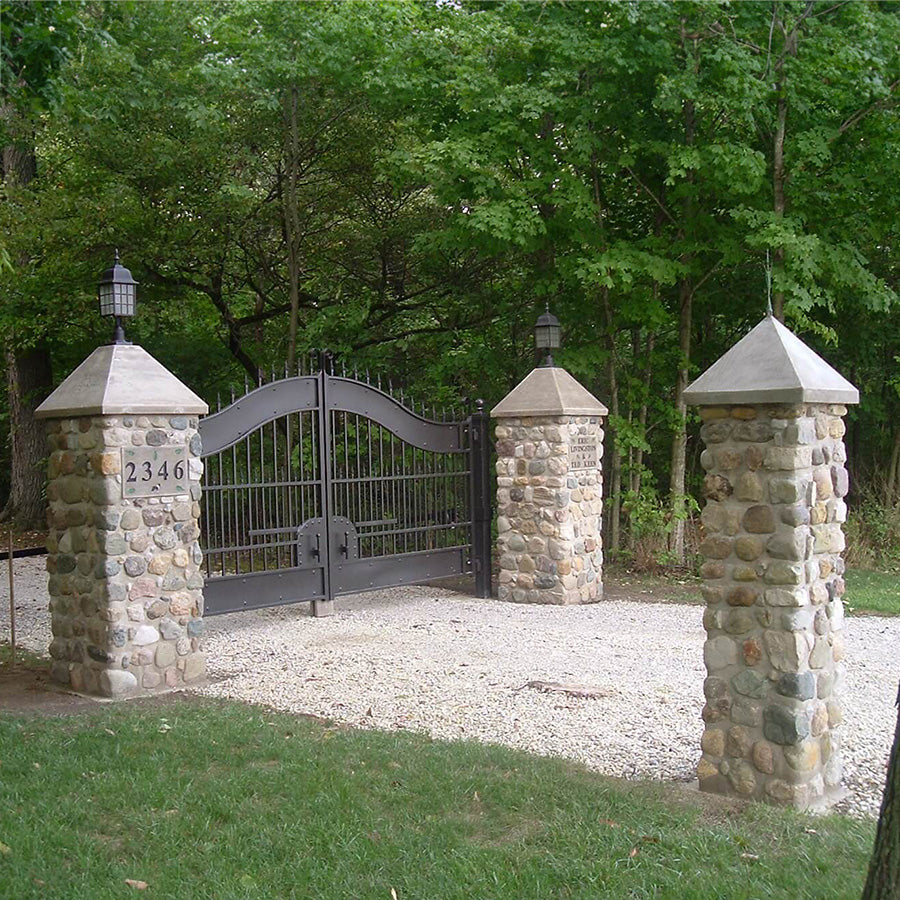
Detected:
[0,699,873,900]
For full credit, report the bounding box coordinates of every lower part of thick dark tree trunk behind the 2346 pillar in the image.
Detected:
[2,346,52,531]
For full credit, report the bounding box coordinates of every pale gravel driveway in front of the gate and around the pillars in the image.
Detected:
[0,558,900,815]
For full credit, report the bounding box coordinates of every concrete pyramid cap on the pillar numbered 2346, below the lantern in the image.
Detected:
[35,344,209,419]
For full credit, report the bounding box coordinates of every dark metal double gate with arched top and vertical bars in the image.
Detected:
[200,358,491,615]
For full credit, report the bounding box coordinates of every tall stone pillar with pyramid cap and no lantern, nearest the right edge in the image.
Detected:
[686,318,858,809]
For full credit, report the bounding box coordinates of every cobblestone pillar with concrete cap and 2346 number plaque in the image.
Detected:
[37,345,207,698]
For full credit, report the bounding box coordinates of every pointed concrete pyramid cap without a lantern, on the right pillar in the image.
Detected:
[684,316,859,406]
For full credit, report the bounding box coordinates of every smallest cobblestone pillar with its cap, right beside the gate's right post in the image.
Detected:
[491,366,607,604]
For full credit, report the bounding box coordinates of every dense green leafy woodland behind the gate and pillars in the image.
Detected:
[0,0,900,566]
